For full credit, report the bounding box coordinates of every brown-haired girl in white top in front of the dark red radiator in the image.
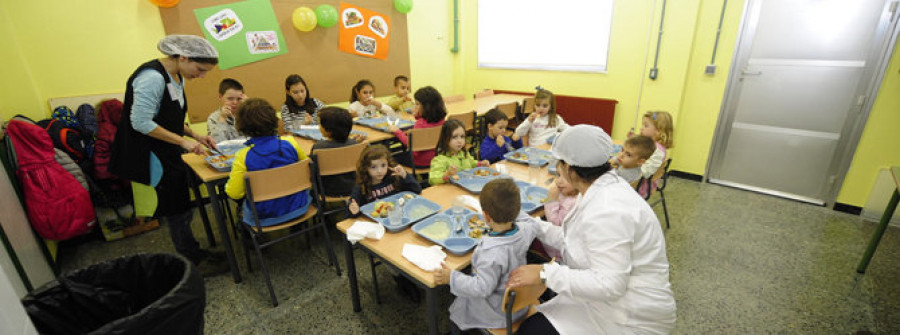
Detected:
[516,87,569,147]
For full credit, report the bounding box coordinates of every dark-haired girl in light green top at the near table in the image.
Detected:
[428,119,491,185]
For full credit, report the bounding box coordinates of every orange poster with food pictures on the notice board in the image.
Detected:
[338,2,391,59]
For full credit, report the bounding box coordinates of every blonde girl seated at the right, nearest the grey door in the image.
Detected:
[638,111,674,198]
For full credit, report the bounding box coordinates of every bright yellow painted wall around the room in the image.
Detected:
[0,0,900,206]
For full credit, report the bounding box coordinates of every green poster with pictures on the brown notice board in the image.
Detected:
[194,0,287,70]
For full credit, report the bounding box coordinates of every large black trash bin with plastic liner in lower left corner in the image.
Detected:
[22,254,206,335]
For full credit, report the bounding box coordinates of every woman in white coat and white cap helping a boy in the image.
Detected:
[507,125,675,334]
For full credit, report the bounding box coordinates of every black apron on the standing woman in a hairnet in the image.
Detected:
[110,60,191,217]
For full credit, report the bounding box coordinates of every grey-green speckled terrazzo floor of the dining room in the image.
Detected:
[60,178,900,334]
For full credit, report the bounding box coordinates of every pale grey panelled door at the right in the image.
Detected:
[707,0,896,204]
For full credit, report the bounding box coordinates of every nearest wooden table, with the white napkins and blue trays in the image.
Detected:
[337,161,551,334]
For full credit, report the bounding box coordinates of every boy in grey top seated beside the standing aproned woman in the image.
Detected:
[206,78,247,143]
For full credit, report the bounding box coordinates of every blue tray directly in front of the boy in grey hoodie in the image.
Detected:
[412,209,486,256]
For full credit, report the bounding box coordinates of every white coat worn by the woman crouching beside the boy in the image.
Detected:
[538,172,675,334]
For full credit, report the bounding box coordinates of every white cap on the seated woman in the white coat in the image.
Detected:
[550,124,613,167]
